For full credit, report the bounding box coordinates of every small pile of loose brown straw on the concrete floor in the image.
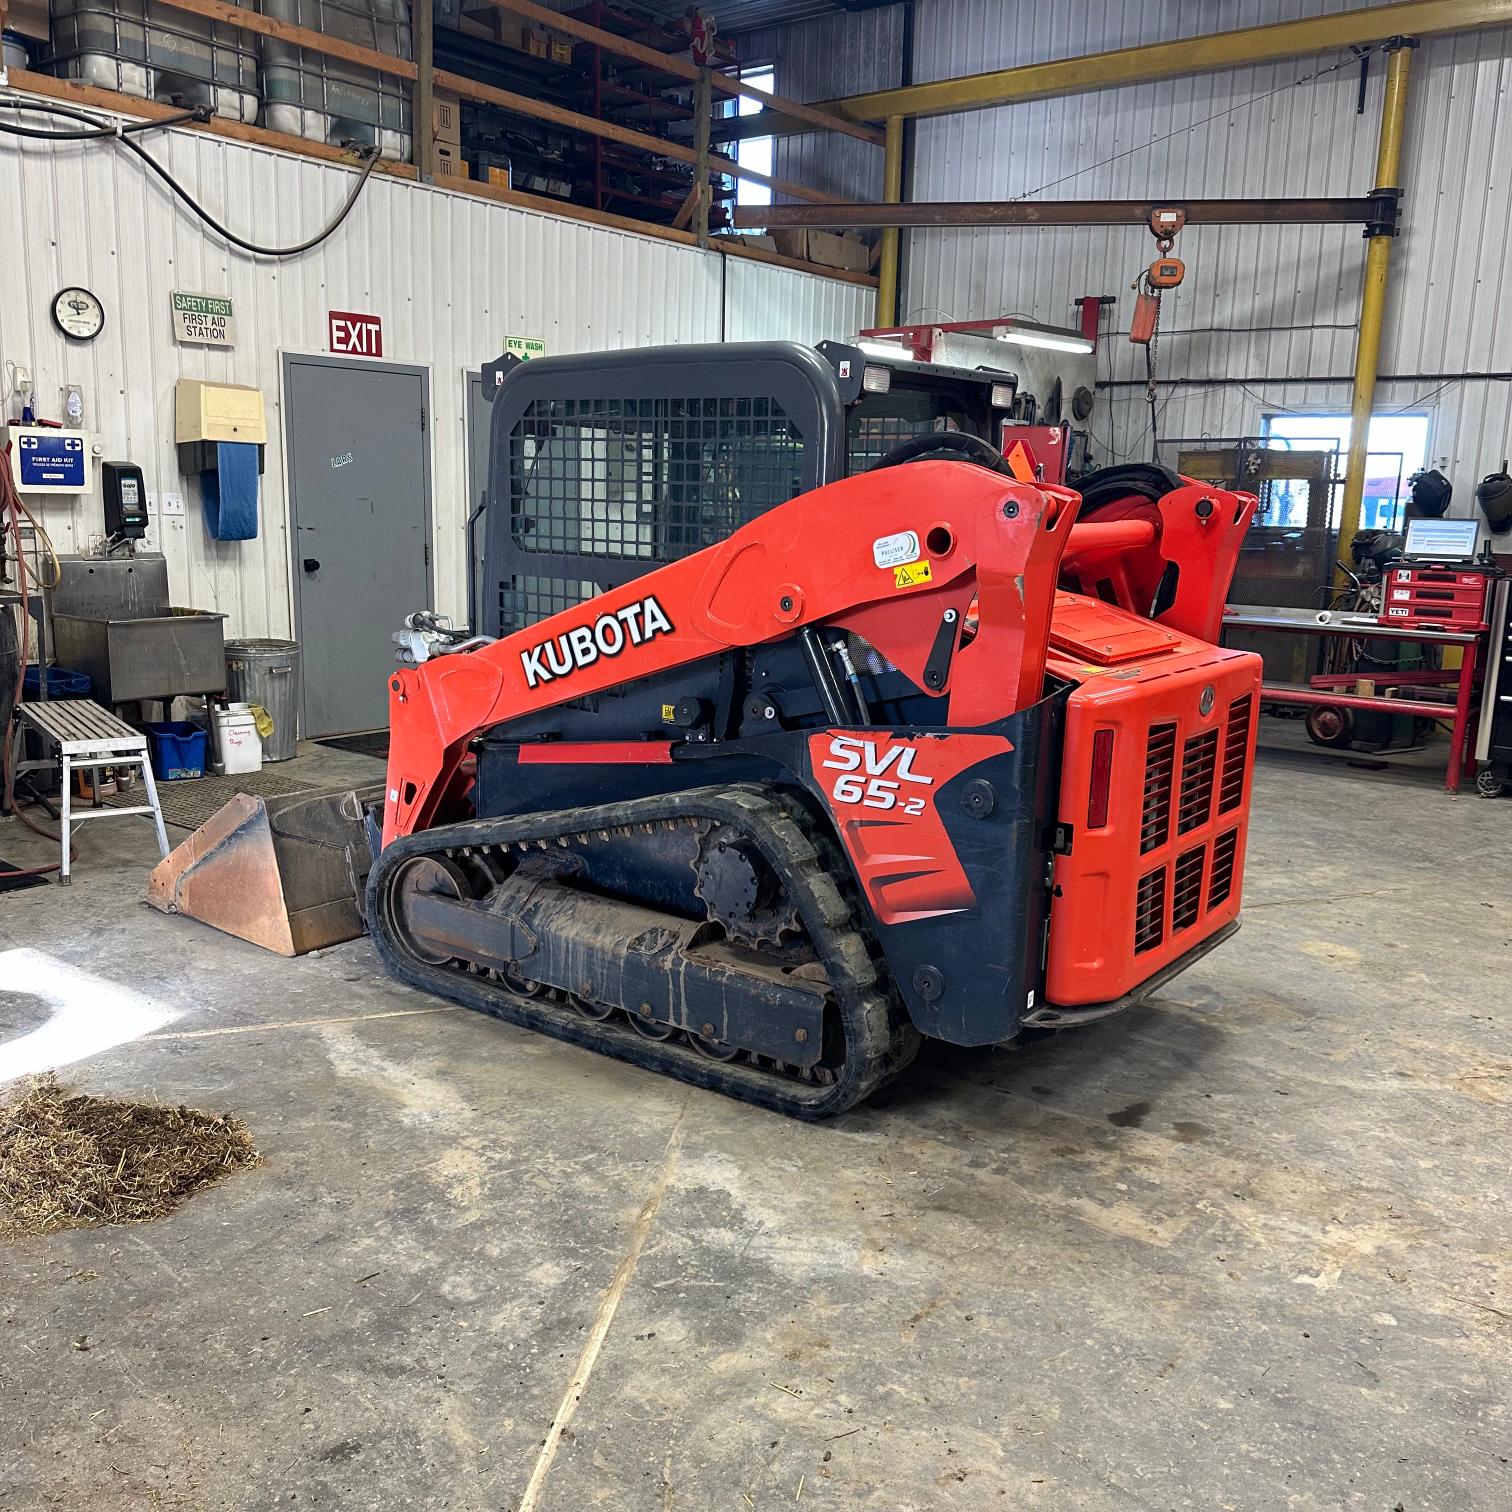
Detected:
[0,1077,262,1237]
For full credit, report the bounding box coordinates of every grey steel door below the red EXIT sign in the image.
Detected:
[284,357,431,739]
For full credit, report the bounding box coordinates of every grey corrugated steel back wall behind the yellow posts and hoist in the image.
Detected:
[779,0,1512,489]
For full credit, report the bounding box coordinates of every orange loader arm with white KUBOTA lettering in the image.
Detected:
[383,461,1077,845]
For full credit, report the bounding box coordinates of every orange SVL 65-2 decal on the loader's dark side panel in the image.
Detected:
[809,730,1013,924]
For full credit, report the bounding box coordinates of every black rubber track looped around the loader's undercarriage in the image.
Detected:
[367,786,919,1119]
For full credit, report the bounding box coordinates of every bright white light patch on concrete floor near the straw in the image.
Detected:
[0,948,178,1083]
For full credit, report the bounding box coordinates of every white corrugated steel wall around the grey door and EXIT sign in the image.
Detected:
[0,120,872,635]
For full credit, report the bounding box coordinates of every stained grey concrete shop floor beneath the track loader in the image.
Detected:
[0,734,1512,1512]
